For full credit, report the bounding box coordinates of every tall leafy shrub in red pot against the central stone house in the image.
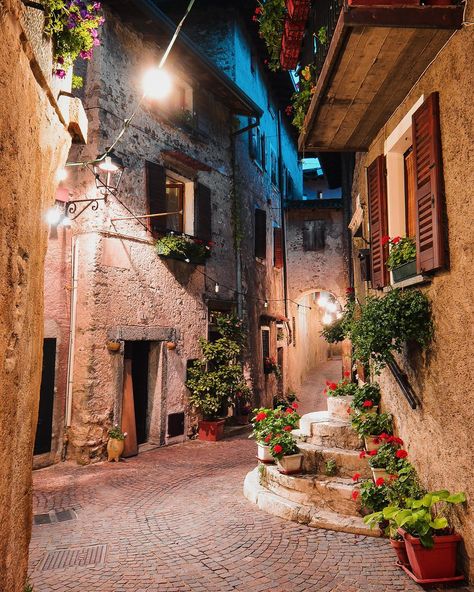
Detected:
[186,315,250,442]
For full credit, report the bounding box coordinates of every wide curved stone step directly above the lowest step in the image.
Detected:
[259,465,359,516]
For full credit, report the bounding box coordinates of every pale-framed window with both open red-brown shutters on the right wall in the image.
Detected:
[367,93,444,289]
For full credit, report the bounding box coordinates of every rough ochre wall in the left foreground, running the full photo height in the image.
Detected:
[0,0,70,592]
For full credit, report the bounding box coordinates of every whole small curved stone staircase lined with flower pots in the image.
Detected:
[244,411,379,536]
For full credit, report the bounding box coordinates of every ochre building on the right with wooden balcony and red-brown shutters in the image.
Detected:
[300,0,474,576]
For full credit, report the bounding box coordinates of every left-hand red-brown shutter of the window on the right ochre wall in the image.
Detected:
[367,155,388,289]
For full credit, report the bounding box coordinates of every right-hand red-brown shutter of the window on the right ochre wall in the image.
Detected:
[412,93,444,273]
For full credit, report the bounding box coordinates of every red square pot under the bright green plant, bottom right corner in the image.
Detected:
[398,528,462,580]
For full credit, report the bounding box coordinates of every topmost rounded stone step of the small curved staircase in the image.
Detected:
[299,411,362,450]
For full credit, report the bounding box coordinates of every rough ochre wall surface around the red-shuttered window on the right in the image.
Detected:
[353,1,474,577]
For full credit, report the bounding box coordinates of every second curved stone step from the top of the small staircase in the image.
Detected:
[298,442,372,478]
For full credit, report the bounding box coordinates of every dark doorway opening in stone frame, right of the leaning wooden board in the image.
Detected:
[125,341,150,444]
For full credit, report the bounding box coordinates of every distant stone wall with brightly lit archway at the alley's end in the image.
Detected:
[286,200,348,389]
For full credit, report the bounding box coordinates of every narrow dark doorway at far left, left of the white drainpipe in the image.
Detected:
[33,339,56,454]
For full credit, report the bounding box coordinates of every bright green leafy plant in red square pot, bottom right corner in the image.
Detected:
[385,490,466,584]
